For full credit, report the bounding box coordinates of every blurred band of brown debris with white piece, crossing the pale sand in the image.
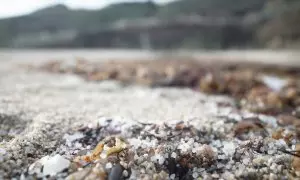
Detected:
[40,59,300,114]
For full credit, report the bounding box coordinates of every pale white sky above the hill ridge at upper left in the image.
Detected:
[0,0,172,18]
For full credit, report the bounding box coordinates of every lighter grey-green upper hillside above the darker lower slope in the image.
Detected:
[0,0,300,47]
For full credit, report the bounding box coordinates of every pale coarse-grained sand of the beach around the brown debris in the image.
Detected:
[0,48,299,179]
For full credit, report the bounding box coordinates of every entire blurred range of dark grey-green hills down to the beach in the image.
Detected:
[0,0,300,49]
